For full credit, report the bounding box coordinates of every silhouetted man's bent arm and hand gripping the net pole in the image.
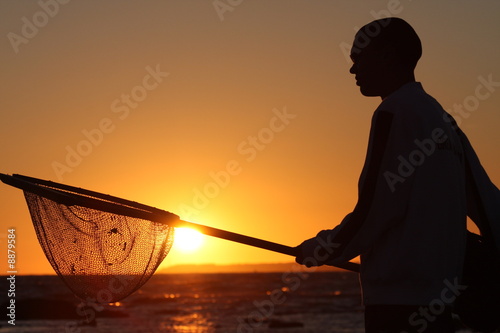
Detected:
[296,110,411,266]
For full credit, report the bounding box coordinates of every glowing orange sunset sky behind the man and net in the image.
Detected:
[0,0,500,274]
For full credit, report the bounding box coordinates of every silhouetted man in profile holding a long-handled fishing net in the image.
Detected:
[296,18,500,333]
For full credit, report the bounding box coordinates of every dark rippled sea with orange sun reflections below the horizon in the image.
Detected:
[0,271,364,333]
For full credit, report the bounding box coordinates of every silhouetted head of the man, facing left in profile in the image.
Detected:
[350,17,422,98]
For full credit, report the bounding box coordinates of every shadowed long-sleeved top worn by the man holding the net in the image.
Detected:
[318,82,468,305]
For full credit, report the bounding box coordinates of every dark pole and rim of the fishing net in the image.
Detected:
[0,173,359,272]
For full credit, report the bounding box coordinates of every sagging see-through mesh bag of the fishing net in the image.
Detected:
[24,191,174,303]
